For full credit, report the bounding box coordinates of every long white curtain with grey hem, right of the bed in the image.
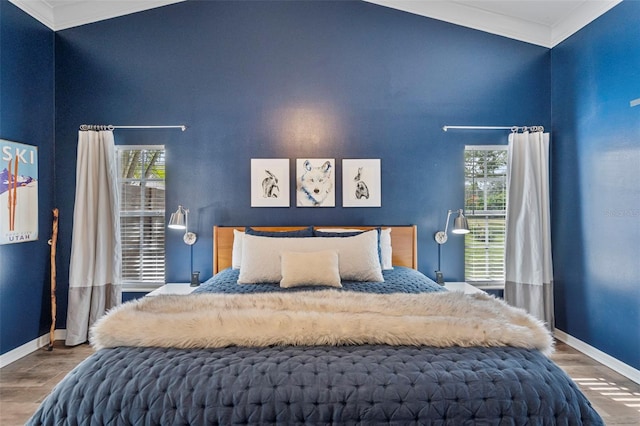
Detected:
[504,132,554,330]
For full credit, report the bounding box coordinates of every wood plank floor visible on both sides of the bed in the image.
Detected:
[0,342,640,426]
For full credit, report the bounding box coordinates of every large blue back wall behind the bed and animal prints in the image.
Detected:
[56,1,551,300]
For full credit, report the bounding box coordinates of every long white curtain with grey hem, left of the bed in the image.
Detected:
[66,131,122,346]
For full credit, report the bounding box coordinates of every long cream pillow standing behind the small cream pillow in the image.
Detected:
[238,230,384,284]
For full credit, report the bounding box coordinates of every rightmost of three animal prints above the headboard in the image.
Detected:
[342,159,382,207]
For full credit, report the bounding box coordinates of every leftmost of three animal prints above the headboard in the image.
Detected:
[251,158,290,207]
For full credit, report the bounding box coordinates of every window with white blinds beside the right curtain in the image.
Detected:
[464,145,507,286]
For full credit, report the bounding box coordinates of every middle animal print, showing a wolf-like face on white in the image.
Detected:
[296,158,336,207]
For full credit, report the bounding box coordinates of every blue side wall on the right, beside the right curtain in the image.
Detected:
[551,1,640,369]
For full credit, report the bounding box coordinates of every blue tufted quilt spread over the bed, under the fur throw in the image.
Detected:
[28,268,603,426]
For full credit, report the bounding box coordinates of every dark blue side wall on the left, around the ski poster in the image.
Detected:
[0,1,55,353]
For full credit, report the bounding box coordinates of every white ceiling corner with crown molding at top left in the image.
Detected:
[9,0,184,31]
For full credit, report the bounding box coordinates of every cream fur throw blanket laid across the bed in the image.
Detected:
[91,290,553,354]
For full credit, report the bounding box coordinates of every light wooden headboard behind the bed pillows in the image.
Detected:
[213,225,418,274]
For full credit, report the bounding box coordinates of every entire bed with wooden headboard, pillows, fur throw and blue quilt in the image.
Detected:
[28,226,603,425]
